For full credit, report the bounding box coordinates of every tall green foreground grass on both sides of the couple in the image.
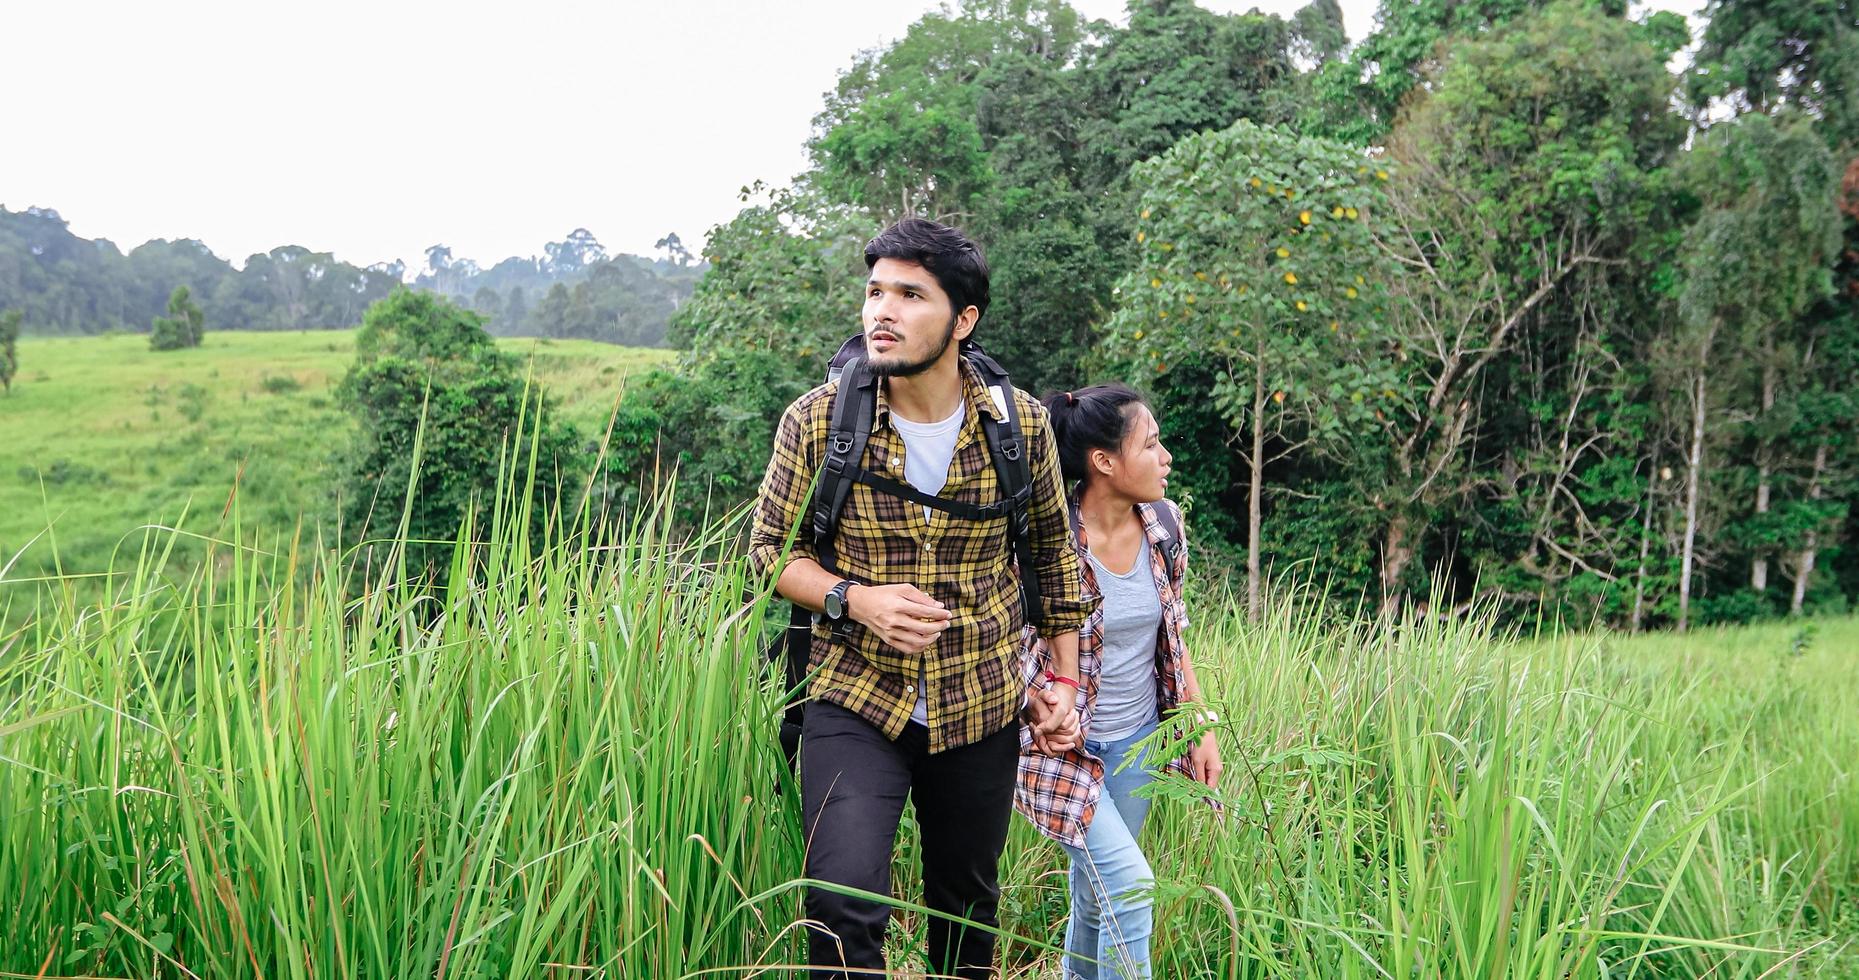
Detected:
[0,476,1859,980]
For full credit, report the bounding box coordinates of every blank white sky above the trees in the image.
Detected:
[0,0,1699,268]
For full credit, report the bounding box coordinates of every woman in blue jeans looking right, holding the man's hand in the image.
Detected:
[1015,383,1221,980]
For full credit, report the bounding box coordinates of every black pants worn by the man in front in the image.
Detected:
[801,701,1021,978]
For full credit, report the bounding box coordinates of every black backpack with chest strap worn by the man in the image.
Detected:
[770,333,1045,766]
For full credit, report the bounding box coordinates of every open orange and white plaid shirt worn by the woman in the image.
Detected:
[1013,500,1190,848]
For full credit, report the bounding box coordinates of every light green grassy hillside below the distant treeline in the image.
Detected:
[0,331,669,603]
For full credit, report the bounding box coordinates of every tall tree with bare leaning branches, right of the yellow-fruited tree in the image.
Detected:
[1366,4,1684,604]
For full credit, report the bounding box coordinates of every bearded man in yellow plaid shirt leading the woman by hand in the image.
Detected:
[749,218,1089,978]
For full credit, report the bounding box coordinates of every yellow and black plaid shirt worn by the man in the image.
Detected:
[749,361,1091,751]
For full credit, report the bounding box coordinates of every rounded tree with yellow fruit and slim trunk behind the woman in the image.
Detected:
[1106,121,1392,621]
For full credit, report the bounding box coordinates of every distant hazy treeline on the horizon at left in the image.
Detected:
[0,206,703,346]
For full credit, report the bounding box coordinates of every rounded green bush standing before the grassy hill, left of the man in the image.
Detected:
[338,290,586,571]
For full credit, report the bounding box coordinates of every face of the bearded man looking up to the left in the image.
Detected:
[864,258,976,377]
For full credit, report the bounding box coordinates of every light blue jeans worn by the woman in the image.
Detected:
[1065,722,1156,980]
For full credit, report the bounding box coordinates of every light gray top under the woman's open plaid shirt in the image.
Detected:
[1086,541,1162,742]
